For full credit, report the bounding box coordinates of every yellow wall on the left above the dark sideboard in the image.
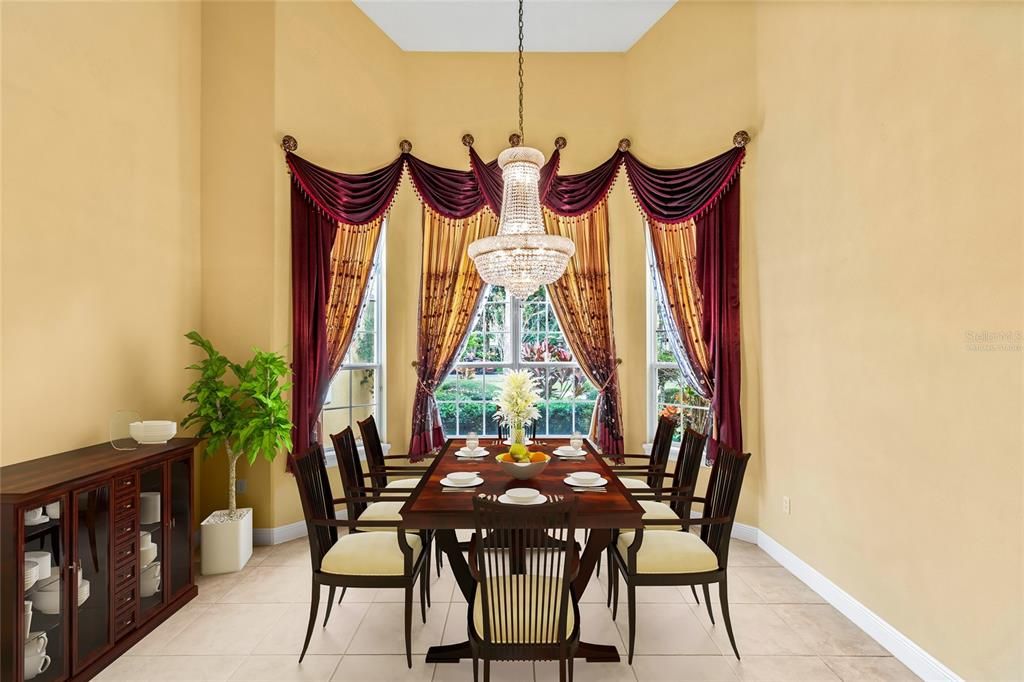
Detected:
[0,2,201,464]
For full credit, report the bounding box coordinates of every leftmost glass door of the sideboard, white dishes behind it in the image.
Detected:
[22,498,71,682]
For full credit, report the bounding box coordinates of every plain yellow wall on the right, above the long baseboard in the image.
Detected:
[746,3,1024,680]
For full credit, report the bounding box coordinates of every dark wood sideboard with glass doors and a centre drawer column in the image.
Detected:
[0,438,199,682]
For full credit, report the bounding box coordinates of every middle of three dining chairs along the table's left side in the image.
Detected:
[331,426,433,606]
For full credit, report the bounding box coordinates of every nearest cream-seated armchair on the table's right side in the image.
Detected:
[608,444,751,665]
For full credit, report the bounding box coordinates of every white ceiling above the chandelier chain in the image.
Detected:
[354,0,676,52]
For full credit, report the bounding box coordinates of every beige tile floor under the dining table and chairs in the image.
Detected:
[97,539,918,682]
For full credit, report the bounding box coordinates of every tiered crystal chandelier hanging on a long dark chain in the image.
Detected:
[469,0,575,299]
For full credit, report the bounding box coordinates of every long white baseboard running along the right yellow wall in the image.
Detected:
[757,523,963,682]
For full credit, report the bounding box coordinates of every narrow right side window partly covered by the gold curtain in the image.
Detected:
[647,238,711,441]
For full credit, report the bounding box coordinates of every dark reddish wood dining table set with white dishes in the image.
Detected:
[400,438,643,663]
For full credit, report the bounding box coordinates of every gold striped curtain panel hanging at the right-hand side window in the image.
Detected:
[648,220,712,398]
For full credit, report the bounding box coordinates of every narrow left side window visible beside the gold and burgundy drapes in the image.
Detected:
[321,228,384,445]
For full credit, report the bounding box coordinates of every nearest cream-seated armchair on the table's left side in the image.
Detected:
[289,443,430,668]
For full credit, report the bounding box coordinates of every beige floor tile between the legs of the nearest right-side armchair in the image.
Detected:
[615,603,720,655]
